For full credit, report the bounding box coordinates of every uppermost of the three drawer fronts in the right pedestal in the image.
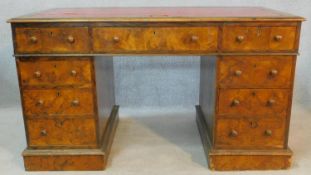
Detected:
[218,56,295,88]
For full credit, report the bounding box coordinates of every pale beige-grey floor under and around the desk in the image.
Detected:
[0,106,311,175]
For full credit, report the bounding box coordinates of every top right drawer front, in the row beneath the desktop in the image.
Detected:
[222,25,297,52]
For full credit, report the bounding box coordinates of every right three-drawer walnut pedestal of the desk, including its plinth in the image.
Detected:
[200,55,296,171]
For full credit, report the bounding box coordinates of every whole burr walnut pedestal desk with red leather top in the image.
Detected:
[9,7,304,171]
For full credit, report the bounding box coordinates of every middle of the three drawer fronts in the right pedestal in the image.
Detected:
[218,89,290,117]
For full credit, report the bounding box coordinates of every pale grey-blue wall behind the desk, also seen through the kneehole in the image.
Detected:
[0,0,311,109]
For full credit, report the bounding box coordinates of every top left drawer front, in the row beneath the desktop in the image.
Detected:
[15,27,90,53]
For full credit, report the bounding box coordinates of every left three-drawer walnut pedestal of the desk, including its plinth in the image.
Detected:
[16,57,118,171]
